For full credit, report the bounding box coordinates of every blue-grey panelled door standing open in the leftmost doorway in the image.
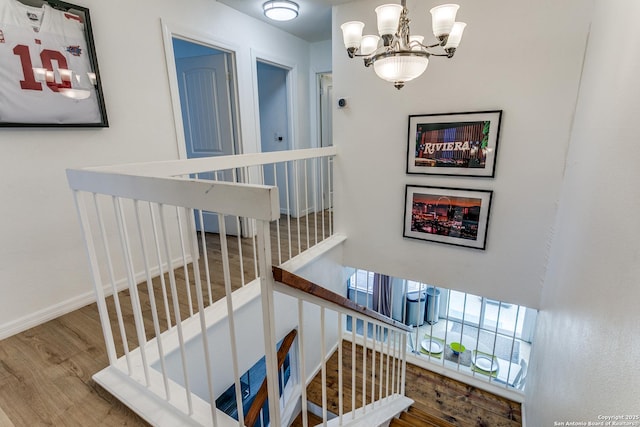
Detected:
[176,49,239,235]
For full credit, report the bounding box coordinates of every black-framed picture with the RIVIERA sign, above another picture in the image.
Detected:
[407,110,502,178]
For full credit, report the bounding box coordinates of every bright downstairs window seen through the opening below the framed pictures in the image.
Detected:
[346,269,537,389]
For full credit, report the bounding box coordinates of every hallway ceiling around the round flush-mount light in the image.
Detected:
[218,0,349,43]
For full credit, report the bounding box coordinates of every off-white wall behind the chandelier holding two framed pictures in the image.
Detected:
[333,0,589,307]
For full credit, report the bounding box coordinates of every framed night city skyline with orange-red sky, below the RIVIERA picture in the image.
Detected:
[404,185,493,249]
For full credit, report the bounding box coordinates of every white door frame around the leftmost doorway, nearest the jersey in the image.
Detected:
[160,19,243,160]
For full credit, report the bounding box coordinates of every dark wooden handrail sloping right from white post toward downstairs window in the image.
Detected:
[271,265,413,332]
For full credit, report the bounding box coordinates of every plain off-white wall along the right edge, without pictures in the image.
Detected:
[527,0,640,426]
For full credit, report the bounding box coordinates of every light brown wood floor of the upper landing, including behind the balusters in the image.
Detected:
[0,212,330,427]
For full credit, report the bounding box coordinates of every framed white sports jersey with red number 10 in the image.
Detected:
[0,0,108,127]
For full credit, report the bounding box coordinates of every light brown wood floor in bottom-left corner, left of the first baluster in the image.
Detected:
[0,304,147,427]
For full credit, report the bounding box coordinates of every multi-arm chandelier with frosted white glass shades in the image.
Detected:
[340,0,467,89]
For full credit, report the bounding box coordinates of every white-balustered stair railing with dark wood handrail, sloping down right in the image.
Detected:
[273,267,412,427]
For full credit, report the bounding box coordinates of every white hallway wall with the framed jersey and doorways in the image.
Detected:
[0,0,318,338]
